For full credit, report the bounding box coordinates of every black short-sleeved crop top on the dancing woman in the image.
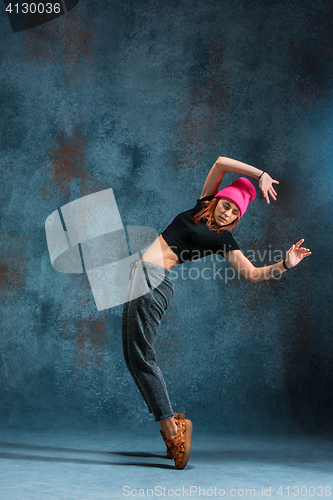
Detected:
[161,194,240,263]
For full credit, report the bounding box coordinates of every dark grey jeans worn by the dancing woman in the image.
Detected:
[122,260,174,422]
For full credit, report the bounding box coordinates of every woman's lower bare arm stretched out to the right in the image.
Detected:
[225,239,311,283]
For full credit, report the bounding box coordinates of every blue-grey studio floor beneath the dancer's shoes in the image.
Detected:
[0,424,333,500]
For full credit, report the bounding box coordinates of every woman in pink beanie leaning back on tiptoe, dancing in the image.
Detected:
[122,157,311,469]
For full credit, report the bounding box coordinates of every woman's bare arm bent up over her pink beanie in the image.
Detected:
[200,156,279,203]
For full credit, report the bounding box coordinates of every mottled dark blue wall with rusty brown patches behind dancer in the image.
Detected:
[0,0,333,431]
